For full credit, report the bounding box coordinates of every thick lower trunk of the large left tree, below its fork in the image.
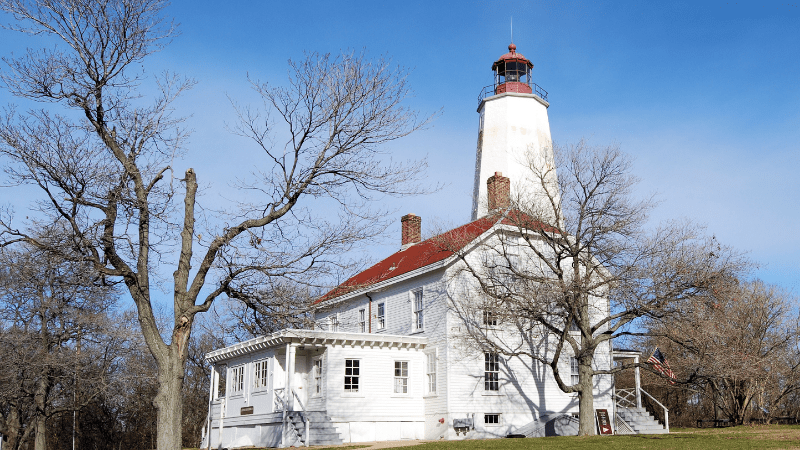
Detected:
[153,352,186,450]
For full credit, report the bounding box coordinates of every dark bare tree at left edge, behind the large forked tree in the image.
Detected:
[0,246,125,450]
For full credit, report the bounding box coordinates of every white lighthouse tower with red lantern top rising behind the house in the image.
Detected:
[472,43,560,220]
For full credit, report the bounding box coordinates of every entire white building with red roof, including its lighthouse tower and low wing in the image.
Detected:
[202,44,668,448]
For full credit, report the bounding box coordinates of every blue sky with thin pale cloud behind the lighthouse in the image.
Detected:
[0,1,800,293]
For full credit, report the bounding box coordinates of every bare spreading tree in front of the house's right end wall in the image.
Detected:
[440,142,741,435]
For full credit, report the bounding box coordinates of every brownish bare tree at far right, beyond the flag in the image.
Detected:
[649,280,800,424]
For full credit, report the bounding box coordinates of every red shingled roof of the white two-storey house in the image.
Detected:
[314,211,556,304]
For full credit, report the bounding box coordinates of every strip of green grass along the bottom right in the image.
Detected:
[378,425,800,450]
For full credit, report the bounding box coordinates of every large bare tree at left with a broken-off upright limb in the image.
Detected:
[0,0,427,450]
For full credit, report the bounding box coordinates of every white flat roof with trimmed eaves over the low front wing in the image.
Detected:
[206,329,428,363]
